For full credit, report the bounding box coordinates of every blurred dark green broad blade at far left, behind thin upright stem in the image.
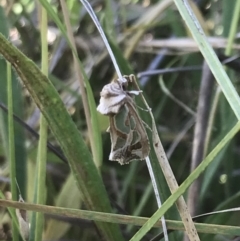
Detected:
[0,6,26,198]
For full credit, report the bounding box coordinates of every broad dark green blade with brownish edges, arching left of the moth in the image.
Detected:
[0,34,122,241]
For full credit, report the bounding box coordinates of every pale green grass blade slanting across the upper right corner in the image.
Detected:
[174,0,240,120]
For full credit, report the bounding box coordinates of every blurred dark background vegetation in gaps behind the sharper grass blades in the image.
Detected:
[0,0,240,240]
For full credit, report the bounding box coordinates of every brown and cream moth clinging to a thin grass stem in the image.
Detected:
[97,75,150,165]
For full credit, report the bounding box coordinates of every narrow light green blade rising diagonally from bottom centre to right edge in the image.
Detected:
[131,122,240,241]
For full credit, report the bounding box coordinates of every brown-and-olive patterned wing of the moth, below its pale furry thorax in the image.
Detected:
[109,101,150,164]
